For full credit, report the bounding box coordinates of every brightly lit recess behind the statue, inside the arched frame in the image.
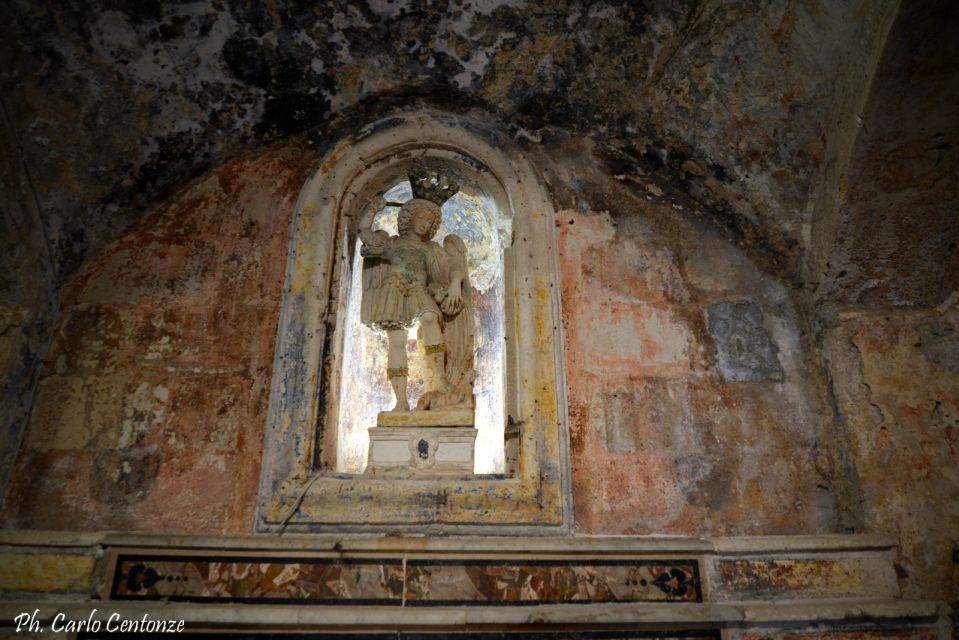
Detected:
[328,159,515,474]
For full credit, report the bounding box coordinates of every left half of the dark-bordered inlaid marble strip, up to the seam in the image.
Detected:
[111,555,403,605]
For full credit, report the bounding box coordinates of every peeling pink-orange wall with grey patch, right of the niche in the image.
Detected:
[547,140,835,535]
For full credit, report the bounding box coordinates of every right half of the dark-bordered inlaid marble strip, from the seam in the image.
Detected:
[406,560,702,605]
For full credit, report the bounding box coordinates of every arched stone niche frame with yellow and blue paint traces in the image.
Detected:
[256,111,571,533]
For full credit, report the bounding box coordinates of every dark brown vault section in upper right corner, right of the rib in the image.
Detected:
[819,2,959,307]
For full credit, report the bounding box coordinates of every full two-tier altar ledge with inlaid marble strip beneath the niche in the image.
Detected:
[0,531,952,640]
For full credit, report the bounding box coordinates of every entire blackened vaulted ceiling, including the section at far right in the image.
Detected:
[0,0,959,304]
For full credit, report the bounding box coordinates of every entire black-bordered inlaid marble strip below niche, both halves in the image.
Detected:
[110,554,702,606]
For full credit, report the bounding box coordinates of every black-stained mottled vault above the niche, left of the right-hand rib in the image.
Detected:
[0,0,896,288]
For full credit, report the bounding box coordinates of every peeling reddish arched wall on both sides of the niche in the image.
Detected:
[5,130,831,535]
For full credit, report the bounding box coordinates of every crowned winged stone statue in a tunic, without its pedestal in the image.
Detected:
[359,170,475,413]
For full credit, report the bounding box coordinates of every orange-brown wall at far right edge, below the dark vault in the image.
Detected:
[829,309,959,605]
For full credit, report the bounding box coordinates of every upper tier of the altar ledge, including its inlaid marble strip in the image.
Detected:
[0,531,900,608]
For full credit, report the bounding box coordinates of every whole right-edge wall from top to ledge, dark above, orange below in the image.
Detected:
[816,2,959,606]
